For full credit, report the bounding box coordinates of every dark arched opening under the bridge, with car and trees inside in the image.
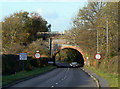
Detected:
[55,48,84,68]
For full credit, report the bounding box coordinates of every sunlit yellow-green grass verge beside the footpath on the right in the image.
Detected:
[85,66,118,87]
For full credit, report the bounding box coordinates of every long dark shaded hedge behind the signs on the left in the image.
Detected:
[2,54,49,75]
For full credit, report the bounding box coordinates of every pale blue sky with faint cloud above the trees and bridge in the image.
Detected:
[0,0,87,32]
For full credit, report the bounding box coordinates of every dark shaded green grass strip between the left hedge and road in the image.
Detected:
[2,66,55,86]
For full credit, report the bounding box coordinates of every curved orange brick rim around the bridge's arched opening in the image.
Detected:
[52,45,86,63]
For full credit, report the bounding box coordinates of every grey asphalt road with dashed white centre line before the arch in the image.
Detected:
[11,68,97,87]
